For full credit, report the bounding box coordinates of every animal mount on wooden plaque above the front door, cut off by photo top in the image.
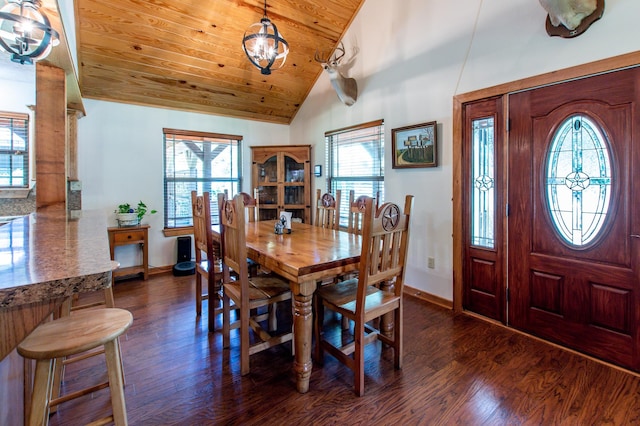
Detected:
[539,0,604,38]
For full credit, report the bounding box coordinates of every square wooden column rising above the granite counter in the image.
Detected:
[35,62,67,211]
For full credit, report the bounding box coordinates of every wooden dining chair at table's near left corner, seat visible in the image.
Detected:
[218,194,293,376]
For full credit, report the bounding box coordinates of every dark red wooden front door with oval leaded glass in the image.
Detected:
[508,69,640,370]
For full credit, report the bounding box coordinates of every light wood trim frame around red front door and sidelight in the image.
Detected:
[453,51,640,312]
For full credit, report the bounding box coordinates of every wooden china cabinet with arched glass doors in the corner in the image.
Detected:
[251,145,311,223]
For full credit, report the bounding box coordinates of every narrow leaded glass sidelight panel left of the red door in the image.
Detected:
[471,117,495,248]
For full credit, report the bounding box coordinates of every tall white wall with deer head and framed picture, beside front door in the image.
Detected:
[290,0,640,300]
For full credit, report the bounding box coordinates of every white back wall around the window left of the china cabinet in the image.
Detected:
[78,99,289,267]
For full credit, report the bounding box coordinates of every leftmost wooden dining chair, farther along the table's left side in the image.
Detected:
[191,191,222,330]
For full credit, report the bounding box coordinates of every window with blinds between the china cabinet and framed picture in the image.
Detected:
[324,120,384,227]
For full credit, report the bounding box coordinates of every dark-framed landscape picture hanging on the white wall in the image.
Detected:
[391,121,438,169]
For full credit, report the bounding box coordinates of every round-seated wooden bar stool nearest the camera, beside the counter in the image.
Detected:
[18,308,133,425]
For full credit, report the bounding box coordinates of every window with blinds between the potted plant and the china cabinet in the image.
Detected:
[163,129,242,228]
